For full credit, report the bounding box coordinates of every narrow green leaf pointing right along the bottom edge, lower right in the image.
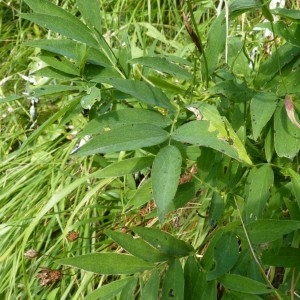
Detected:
[219,274,273,294]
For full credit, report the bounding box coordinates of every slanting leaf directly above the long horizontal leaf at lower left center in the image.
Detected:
[104,230,170,262]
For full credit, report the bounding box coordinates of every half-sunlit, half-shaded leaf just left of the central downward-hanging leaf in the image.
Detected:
[94,156,154,178]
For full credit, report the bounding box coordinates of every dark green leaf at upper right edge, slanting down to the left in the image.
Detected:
[254,43,300,89]
